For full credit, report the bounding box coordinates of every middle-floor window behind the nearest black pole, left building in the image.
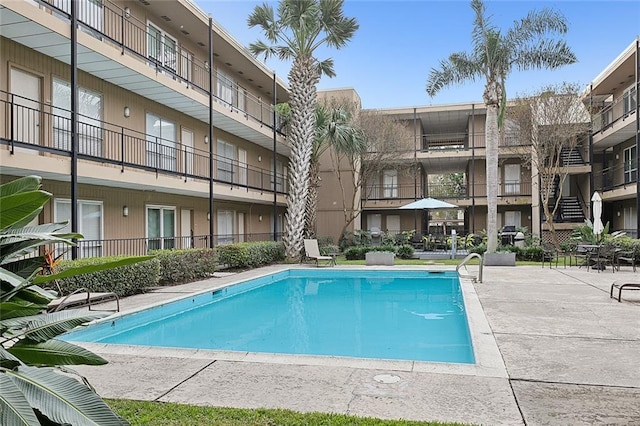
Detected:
[52,78,102,157]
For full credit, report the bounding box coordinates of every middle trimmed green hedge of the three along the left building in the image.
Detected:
[149,248,218,285]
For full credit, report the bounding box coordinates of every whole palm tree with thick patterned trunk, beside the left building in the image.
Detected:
[248,0,358,259]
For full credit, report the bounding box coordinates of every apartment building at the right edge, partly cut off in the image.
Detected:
[583,38,640,238]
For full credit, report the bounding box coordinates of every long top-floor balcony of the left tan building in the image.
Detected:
[0,0,288,155]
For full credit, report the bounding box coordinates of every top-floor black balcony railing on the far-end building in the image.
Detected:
[422,133,531,151]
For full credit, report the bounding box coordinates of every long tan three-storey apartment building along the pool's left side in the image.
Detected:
[0,0,289,257]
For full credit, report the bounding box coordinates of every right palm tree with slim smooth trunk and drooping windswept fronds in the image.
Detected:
[427,0,576,253]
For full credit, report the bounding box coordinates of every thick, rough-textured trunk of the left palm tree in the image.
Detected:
[283,57,320,259]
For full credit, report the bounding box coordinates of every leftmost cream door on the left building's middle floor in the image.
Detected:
[11,68,42,154]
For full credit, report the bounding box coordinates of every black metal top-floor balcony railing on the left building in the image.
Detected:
[35,0,278,128]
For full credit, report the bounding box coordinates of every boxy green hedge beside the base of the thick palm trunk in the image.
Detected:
[216,241,284,269]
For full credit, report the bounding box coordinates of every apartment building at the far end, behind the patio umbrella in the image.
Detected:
[318,89,591,245]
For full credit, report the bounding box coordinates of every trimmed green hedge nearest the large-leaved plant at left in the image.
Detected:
[56,256,160,297]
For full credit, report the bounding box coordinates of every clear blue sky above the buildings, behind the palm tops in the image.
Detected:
[201,0,640,108]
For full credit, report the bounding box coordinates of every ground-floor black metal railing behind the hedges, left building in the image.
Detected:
[50,233,282,259]
